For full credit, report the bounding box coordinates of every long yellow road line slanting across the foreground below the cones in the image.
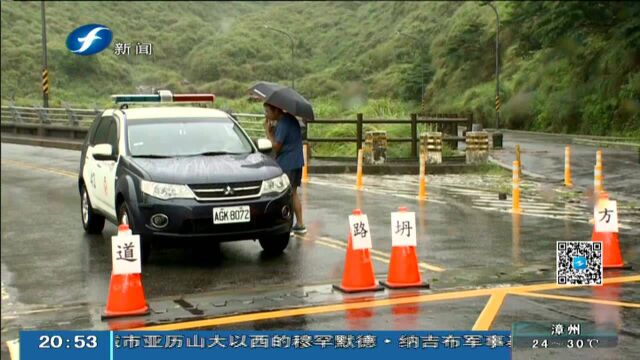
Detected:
[132,275,640,330]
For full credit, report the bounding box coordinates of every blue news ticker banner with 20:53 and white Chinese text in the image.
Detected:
[20,330,511,360]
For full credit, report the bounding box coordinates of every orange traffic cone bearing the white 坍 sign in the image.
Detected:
[381,207,429,289]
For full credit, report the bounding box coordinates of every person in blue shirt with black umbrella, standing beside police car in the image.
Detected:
[249,82,314,234]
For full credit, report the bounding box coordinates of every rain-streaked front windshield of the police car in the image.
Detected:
[128,119,253,157]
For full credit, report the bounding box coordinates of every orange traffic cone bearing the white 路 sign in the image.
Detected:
[333,209,384,293]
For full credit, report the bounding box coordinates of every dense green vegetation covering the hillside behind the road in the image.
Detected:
[1,1,640,137]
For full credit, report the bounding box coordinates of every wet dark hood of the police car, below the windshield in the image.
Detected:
[131,153,282,184]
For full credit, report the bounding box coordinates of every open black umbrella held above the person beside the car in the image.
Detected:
[249,81,315,125]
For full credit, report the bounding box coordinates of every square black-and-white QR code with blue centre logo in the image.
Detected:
[556,241,602,285]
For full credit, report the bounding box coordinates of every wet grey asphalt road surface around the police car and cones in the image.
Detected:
[2,143,640,353]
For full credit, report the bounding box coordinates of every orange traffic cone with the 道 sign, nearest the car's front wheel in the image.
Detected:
[102,224,149,319]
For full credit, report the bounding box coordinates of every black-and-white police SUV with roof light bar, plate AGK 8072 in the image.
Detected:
[78,91,293,261]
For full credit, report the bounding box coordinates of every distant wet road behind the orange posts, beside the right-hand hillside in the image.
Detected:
[493,132,640,203]
